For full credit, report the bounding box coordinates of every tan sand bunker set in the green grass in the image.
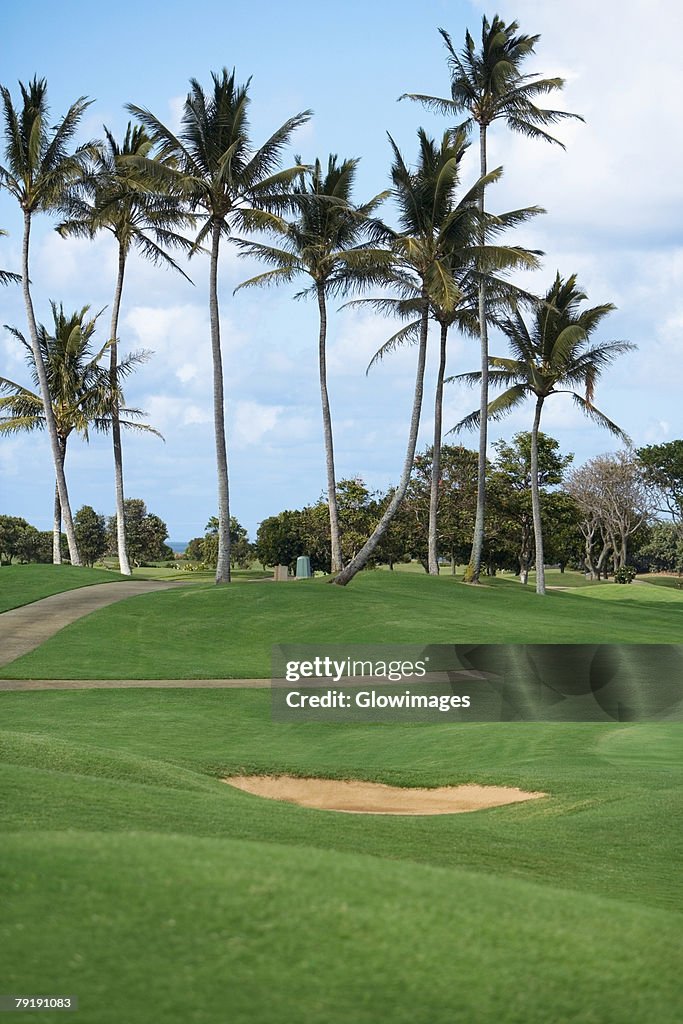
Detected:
[223,775,546,814]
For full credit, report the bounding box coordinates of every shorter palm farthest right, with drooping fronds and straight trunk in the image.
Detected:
[454,273,636,594]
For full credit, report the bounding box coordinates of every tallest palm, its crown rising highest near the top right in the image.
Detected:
[401,15,583,583]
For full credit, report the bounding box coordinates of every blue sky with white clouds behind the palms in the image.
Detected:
[0,0,683,541]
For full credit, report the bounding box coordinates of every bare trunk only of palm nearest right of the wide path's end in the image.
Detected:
[209,221,230,583]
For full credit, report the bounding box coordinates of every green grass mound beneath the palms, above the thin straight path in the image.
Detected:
[0,572,683,679]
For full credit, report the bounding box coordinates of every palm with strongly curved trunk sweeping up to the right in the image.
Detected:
[334,128,483,586]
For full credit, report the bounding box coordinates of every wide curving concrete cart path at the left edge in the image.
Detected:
[0,580,185,666]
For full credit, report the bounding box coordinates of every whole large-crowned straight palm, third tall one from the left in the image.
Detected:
[128,68,310,583]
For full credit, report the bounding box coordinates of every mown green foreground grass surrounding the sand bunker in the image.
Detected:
[0,690,683,1024]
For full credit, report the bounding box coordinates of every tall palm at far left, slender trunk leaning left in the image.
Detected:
[0,78,94,565]
